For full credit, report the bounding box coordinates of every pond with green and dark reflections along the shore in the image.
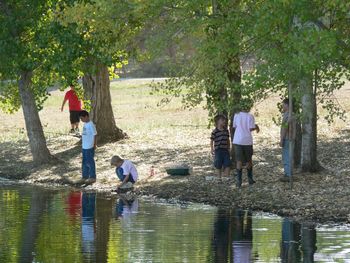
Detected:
[0,186,350,263]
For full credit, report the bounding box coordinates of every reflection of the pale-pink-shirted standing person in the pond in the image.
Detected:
[232,210,253,263]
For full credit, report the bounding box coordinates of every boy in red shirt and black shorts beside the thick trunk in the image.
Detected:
[61,84,81,133]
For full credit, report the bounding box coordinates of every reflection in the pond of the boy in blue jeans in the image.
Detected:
[81,192,96,262]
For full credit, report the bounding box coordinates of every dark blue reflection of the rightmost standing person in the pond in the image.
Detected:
[281,218,301,263]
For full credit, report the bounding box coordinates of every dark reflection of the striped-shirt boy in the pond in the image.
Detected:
[213,209,231,263]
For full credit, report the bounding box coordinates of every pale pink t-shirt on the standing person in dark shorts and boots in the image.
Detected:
[232,112,255,145]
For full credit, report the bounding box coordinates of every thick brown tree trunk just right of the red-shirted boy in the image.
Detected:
[83,62,126,143]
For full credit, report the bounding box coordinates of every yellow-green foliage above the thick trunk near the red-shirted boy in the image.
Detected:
[56,0,139,80]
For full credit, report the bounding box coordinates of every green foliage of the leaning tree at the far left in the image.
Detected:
[0,0,73,113]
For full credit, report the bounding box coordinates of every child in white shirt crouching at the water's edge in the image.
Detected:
[111,155,138,188]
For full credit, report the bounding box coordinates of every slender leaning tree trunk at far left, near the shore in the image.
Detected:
[18,71,52,164]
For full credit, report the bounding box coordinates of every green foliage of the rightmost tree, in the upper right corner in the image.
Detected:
[243,1,350,122]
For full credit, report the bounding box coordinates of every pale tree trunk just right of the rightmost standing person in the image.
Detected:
[300,78,319,172]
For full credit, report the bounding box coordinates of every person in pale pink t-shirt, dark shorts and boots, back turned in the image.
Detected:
[232,99,260,187]
